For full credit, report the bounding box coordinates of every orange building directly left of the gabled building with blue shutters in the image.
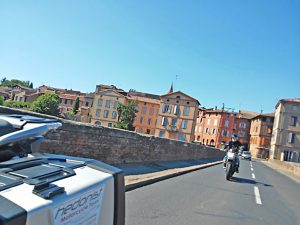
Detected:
[128,91,160,135]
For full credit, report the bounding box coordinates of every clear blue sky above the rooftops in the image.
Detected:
[0,0,300,112]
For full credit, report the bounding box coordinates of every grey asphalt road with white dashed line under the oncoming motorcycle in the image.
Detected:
[126,160,300,225]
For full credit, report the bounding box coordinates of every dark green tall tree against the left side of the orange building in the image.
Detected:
[115,100,136,131]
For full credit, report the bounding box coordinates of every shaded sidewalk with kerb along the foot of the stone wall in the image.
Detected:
[116,159,223,191]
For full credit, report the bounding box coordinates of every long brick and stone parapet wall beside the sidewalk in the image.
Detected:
[0,106,225,164]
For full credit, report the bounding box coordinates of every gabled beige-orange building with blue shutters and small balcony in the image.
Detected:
[155,91,200,142]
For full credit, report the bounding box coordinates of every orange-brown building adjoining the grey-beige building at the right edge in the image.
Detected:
[249,113,274,158]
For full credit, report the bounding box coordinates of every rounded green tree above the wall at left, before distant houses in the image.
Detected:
[30,93,59,116]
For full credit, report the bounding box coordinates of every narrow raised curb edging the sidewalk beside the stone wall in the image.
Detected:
[125,160,223,192]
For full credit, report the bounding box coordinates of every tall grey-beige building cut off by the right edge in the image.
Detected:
[270,98,300,163]
